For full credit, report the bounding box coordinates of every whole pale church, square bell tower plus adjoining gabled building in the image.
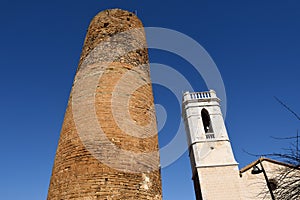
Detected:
[182,90,299,200]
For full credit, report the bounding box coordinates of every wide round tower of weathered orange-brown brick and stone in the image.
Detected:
[47,9,162,200]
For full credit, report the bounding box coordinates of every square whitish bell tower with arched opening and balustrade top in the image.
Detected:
[182,90,242,200]
